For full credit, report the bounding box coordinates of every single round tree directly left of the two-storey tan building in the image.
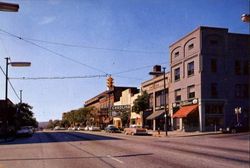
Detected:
[132,91,149,113]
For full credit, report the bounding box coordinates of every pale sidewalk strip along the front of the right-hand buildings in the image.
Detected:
[148,130,222,137]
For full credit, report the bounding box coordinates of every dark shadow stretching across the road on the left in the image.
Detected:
[0,132,120,145]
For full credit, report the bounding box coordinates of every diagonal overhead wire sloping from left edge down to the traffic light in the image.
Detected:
[0,28,108,75]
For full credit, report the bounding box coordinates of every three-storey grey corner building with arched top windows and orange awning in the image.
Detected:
[169,27,250,131]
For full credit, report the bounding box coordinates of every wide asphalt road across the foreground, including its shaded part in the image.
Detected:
[0,131,250,168]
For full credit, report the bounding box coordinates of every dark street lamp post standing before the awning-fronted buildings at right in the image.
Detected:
[149,67,168,136]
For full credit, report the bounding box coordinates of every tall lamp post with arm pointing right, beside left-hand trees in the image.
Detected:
[4,57,31,140]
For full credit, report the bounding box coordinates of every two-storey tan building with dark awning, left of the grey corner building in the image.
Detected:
[141,65,170,130]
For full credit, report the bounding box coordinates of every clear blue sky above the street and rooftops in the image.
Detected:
[0,0,250,121]
